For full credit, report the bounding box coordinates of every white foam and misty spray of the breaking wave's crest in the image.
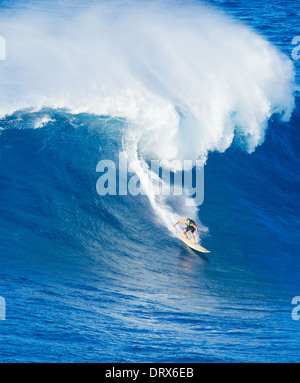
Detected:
[0,2,294,166]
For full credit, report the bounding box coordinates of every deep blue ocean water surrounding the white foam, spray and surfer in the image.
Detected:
[0,0,300,362]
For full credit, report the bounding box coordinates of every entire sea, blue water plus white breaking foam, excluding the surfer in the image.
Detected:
[0,0,300,362]
